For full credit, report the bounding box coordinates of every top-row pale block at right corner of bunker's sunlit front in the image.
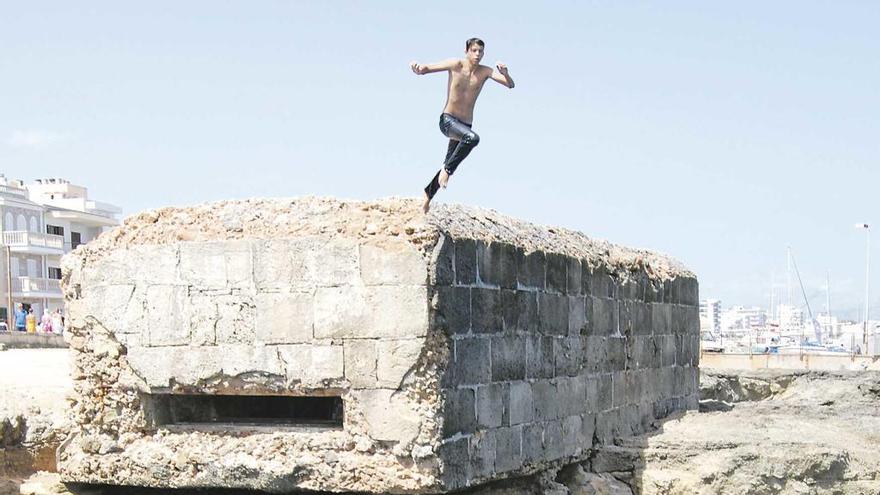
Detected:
[359,241,428,285]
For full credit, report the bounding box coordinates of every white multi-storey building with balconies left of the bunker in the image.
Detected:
[0,174,122,328]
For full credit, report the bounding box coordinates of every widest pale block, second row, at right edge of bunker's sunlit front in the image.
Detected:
[315,286,428,338]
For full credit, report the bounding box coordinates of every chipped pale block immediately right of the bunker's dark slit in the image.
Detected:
[360,388,421,444]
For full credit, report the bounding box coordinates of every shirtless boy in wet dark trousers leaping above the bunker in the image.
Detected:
[409,38,513,213]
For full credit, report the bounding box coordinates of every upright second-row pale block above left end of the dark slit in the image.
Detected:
[146,285,190,347]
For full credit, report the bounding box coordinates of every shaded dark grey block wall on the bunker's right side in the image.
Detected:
[435,238,699,488]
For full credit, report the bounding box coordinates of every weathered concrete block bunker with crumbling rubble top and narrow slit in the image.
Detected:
[59,198,699,493]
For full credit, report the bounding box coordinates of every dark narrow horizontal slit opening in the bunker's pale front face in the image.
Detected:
[150,394,343,428]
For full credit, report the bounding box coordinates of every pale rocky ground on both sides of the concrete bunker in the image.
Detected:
[0,350,880,495]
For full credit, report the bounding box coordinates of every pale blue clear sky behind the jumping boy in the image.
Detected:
[0,1,880,317]
